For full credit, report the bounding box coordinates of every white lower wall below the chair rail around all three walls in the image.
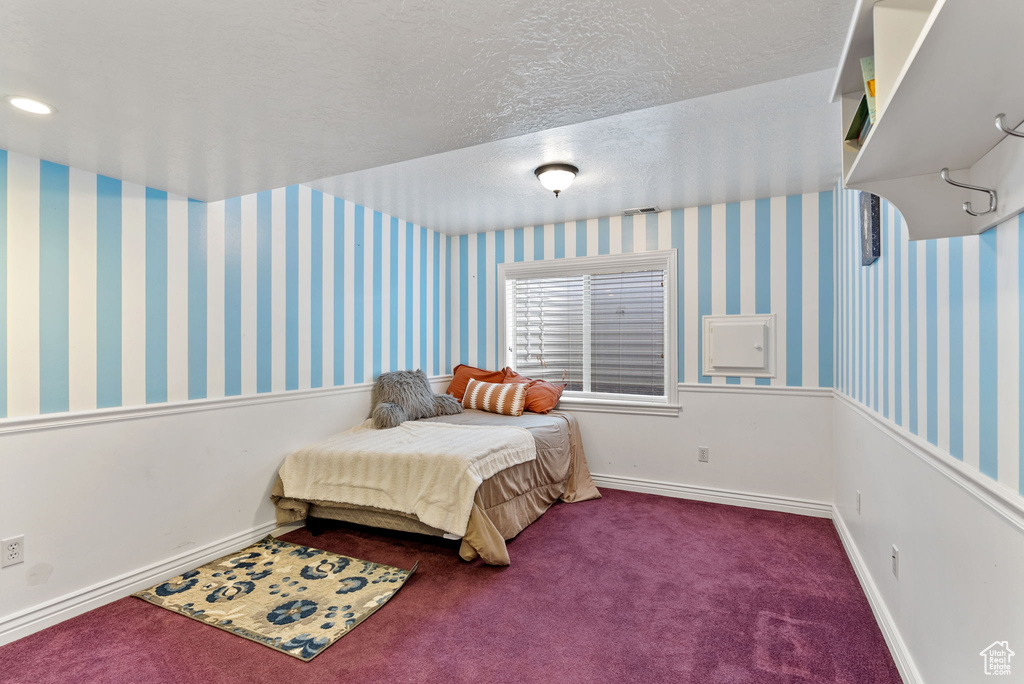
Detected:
[9,378,1024,682]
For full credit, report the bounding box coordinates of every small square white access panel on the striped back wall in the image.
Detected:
[703,313,775,378]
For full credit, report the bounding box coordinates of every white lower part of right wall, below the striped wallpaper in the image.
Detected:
[834,396,1024,684]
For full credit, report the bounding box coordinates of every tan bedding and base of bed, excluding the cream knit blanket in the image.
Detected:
[271,410,601,565]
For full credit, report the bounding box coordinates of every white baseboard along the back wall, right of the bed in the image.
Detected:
[593,474,833,518]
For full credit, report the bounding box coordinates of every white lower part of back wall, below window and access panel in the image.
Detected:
[574,385,833,515]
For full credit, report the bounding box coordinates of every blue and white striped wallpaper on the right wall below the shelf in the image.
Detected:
[836,190,1024,494]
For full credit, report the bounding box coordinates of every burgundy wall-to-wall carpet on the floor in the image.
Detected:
[0,489,900,684]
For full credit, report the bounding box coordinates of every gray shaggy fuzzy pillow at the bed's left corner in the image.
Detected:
[370,370,462,429]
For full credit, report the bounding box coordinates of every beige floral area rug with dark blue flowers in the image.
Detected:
[134,537,419,661]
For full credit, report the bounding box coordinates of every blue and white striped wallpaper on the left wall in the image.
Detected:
[0,151,447,418]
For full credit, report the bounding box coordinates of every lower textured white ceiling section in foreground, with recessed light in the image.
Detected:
[0,0,852,200]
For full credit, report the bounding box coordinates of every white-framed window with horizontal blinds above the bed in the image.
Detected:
[499,250,677,409]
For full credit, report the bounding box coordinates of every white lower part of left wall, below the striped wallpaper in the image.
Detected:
[0,377,450,644]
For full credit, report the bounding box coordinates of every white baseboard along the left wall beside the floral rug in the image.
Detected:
[0,522,292,645]
